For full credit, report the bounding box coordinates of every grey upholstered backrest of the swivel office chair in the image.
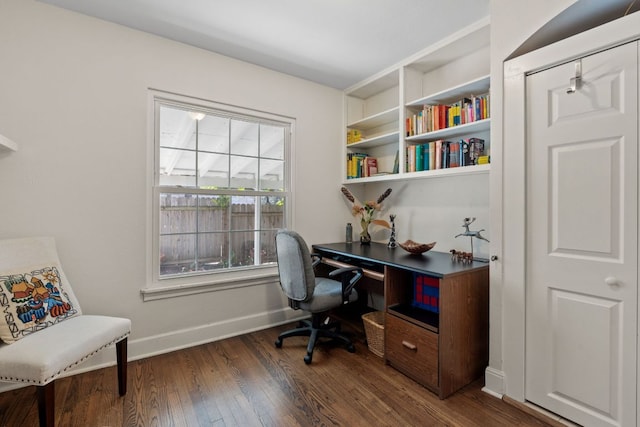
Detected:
[276,230,316,301]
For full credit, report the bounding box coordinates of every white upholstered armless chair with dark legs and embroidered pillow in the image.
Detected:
[0,237,131,426]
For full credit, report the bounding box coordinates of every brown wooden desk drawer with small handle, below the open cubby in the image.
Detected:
[385,313,439,389]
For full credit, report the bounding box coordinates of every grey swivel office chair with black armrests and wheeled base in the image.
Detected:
[275,230,362,365]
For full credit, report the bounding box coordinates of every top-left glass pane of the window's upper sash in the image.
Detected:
[159,106,196,150]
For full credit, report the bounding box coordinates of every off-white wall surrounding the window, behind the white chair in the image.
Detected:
[0,0,348,384]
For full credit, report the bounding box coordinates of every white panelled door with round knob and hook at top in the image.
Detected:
[528,43,638,426]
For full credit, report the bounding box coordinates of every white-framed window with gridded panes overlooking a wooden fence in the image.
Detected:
[153,91,293,290]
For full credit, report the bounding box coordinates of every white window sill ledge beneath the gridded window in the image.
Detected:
[140,267,279,302]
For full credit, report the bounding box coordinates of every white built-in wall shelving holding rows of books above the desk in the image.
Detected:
[342,19,491,184]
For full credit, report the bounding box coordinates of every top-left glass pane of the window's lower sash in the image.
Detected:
[160,193,198,234]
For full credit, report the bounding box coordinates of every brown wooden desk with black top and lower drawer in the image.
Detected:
[312,243,489,399]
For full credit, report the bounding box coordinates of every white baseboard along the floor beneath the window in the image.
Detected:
[0,307,308,393]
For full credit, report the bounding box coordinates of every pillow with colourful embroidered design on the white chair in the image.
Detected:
[0,263,78,344]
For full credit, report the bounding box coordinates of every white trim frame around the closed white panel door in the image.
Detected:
[500,13,640,413]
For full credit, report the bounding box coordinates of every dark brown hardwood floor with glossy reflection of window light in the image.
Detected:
[0,325,557,427]
